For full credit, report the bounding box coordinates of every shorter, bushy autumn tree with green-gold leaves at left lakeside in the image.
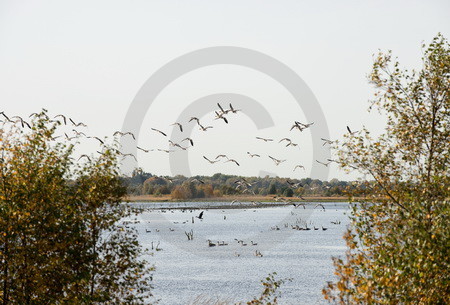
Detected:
[0,111,152,305]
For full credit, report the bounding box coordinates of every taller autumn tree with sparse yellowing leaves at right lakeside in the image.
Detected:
[324,34,450,304]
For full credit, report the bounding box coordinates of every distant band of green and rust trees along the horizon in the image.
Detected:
[124,169,363,199]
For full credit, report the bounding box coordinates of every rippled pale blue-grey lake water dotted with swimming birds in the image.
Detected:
[128,202,349,305]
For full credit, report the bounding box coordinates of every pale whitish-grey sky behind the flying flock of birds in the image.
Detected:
[0,0,450,180]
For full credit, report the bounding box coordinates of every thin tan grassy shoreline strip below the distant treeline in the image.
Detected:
[125,195,349,203]
